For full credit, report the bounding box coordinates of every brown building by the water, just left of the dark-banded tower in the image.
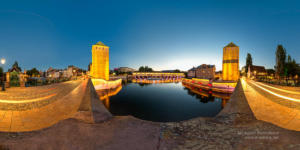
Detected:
[196,64,216,80]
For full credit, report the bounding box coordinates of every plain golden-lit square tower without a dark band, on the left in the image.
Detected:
[90,42,109,80]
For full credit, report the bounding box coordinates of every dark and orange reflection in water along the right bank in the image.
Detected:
[182,83,231,109]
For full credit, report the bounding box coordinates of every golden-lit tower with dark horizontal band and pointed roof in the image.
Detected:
[222,42,240,81]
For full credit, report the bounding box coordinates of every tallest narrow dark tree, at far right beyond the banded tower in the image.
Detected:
[275,45,286,79]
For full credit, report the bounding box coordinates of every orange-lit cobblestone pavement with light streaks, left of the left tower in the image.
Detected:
[0,81,85,132]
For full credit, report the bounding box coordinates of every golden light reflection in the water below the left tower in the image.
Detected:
[96,85,122,108]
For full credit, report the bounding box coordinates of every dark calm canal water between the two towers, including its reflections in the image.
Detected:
[98,82,229,122]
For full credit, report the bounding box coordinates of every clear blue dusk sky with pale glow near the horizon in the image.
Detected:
[0,0,300,71]
